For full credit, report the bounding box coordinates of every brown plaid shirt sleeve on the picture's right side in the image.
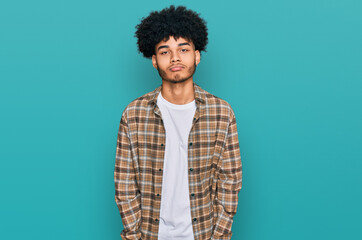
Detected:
[211,114,242,240]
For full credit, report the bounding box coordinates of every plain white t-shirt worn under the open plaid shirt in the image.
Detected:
[157,92,196,240]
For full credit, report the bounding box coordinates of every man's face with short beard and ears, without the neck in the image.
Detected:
[152,36,200,83]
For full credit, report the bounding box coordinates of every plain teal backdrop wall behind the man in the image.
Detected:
[0,0,362,240]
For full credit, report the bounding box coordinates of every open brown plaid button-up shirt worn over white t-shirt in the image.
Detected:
[114,83,242,240]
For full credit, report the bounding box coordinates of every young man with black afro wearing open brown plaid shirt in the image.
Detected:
[114,6,242,240]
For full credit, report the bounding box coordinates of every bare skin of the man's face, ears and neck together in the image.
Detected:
[152,36,200,104]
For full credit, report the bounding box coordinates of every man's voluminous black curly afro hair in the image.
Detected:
[135,5,208,58]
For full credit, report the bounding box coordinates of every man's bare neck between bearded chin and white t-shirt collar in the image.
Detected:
[161,78,195,105]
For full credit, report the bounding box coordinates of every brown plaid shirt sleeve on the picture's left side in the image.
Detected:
[114,115,141,240]
